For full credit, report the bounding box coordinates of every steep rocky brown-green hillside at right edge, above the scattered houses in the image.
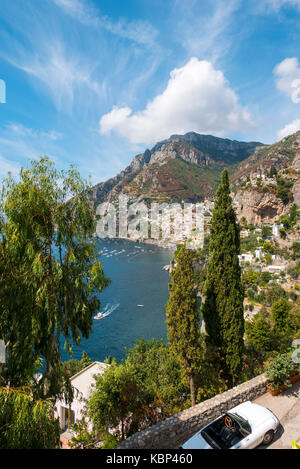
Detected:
[231,132,300,225]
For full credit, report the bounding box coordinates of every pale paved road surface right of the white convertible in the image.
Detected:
[254,381,300,449]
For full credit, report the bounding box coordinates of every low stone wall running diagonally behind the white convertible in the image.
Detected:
[118,375,267,449]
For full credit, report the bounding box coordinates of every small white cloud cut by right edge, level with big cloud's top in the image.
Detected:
[274,57,300,104]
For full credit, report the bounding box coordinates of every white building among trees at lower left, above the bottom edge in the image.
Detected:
[55,362,109,430]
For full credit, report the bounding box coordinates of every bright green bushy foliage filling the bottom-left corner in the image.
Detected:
[0,387,60,449]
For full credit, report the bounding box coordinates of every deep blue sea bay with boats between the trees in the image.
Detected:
[63,240,172,361]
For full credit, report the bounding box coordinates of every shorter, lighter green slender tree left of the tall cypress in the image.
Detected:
[166,246,202,405]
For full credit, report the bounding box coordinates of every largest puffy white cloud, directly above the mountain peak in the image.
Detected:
[100,57,253,143]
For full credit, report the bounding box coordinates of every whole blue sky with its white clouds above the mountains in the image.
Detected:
[0,0,300,183]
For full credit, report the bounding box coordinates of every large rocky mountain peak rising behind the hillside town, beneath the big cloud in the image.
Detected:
[92,132,264,203]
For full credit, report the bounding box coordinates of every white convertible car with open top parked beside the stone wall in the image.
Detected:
[181,401,280,449]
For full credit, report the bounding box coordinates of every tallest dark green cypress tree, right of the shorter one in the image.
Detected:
[202,169,244,384]
